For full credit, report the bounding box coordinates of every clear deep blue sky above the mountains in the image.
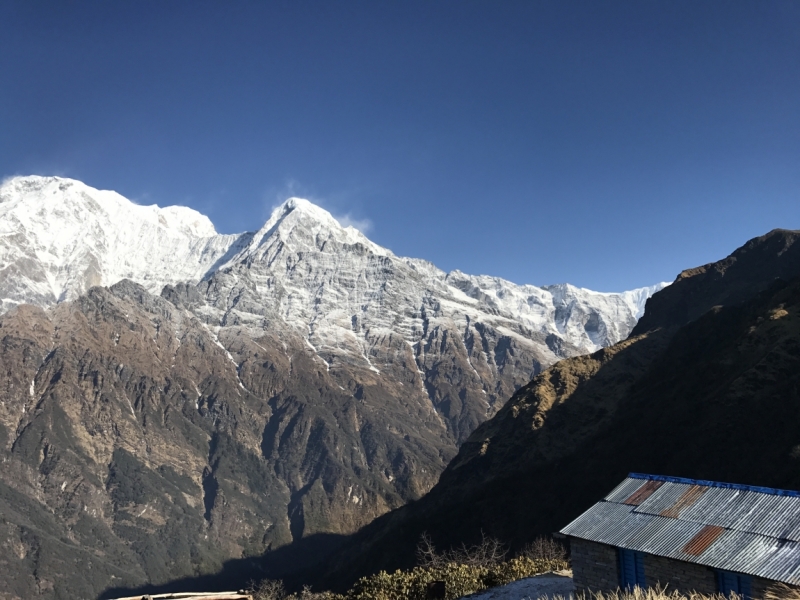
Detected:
[0,0,800,291]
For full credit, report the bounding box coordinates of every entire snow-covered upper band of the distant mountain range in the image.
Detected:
[0,176,666,360]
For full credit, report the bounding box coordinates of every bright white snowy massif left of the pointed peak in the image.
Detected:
[0,176,249,311]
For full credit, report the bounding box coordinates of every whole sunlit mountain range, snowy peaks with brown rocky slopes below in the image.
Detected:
[0,177,662,598]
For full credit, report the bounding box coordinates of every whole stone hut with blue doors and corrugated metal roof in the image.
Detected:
[561,473,800,599]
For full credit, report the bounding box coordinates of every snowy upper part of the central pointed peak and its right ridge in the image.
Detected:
[195,198,666,368]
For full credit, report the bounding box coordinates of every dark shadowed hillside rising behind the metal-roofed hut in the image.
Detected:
[318,230,800,585]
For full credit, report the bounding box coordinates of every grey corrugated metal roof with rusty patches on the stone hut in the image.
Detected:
[561,473,800,585]
